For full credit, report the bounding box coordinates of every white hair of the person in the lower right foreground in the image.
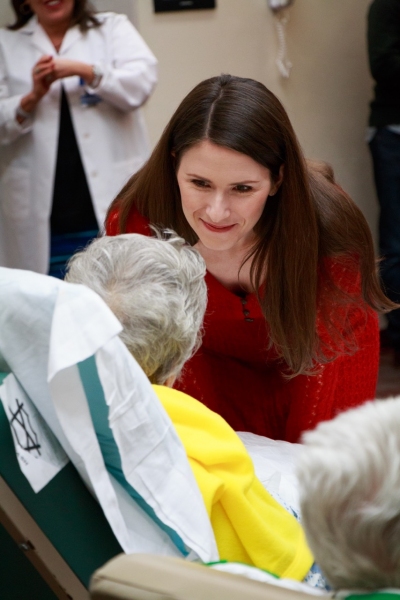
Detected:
[298,397,400,590]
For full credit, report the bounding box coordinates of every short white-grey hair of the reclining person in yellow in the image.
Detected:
[65,230,207,384]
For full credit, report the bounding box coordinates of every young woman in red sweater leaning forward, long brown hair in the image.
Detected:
[106,75,393,441]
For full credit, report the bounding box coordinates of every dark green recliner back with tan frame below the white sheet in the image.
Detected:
[0,373,121,600]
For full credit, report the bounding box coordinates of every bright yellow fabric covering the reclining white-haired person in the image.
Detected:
[153,385,313,580]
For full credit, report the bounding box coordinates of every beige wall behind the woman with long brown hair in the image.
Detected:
[0,0,377,236]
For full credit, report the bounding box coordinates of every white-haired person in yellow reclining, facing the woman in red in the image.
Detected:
[66,232,313,580]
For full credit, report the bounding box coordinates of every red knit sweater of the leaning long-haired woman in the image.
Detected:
[106,209,379,442]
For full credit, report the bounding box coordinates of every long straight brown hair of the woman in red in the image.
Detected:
[109,75,394,375]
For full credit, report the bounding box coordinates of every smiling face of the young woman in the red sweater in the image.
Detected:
[177,140,279,251]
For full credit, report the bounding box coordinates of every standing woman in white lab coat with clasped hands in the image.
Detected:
[0,0,157,276]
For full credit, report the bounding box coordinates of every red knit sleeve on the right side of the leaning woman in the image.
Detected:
[276,259,379,441]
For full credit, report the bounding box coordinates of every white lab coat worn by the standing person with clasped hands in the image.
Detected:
[0,13,157,273]
